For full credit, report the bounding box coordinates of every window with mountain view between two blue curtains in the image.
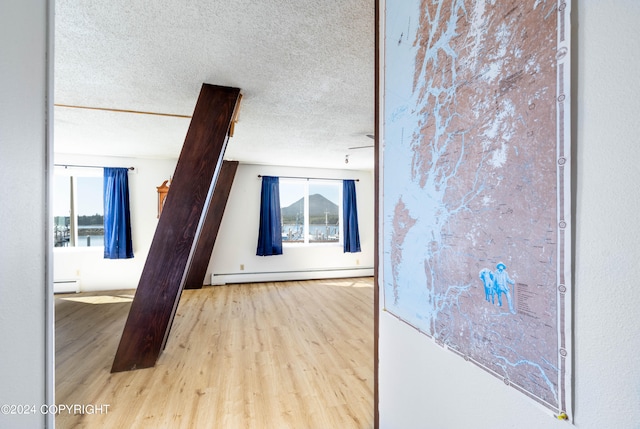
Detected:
[280,179,342,243]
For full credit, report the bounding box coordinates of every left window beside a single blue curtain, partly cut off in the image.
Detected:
[53,169,104,247]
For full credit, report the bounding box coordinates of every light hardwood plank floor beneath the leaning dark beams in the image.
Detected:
[55,278,373,429]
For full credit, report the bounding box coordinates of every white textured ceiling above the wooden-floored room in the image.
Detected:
[54,0,374,169]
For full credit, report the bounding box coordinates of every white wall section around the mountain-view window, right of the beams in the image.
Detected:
[205,164,374,284]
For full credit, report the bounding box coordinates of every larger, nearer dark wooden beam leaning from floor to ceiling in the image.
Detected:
[111,84,240,372]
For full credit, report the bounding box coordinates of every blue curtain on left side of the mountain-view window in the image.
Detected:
[256,176,282,256]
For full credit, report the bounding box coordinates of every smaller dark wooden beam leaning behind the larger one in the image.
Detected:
[184,161,238,289]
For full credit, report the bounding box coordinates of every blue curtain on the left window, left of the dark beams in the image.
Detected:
[103,167,133,259]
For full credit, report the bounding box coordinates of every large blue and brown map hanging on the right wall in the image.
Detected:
[382,0,571,415]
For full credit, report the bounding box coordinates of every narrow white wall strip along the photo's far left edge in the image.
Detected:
[0,0,53,428]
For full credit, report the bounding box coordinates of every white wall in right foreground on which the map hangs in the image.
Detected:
[379,0,640,429]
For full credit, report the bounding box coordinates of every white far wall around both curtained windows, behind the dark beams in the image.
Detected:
[53,157,374,292]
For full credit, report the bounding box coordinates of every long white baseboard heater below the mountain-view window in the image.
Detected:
[211,267,373,285]
